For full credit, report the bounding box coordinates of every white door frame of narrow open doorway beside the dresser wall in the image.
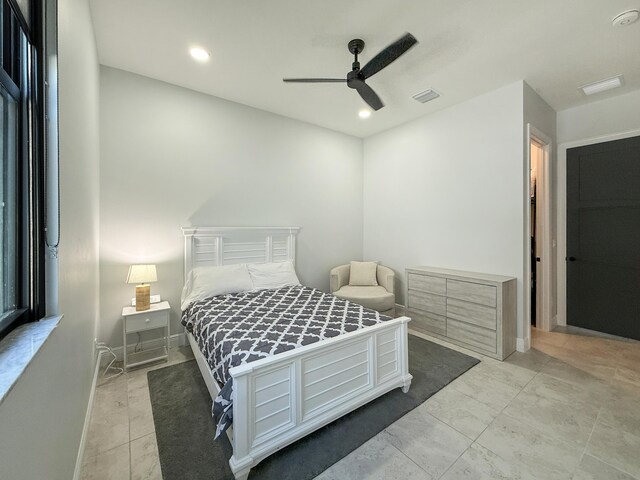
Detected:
[523,123,554,345]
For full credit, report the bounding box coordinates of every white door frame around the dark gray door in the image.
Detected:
[556,129,640,326]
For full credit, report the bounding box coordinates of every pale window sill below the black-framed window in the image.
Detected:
[0,316,62,404]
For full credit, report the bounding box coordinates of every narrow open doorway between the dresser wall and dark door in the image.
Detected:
[525,125,553,340]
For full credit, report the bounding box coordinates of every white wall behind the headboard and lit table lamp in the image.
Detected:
[100,67,362,346]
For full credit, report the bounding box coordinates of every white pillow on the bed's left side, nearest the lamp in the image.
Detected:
[180,263,253,310]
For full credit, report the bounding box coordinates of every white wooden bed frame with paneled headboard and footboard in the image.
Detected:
[182,227,412,480]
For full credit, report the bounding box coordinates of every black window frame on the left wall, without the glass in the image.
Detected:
[0,0,47,339]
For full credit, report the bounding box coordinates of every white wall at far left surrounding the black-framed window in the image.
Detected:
[0,0,99,480]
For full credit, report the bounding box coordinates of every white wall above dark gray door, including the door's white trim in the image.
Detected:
[555,90,640,325]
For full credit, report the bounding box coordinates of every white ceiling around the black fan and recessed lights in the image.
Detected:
[91,0,640,137]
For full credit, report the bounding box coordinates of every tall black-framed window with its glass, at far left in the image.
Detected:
[0,0,44,338]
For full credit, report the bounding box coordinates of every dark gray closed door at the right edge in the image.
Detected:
[567,133,640,340]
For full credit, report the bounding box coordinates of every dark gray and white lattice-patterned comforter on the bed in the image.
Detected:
[182,285,391,438]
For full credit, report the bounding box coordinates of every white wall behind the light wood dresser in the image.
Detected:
[364,82,524,337]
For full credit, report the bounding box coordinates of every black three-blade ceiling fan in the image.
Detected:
[282,33,418,110]
